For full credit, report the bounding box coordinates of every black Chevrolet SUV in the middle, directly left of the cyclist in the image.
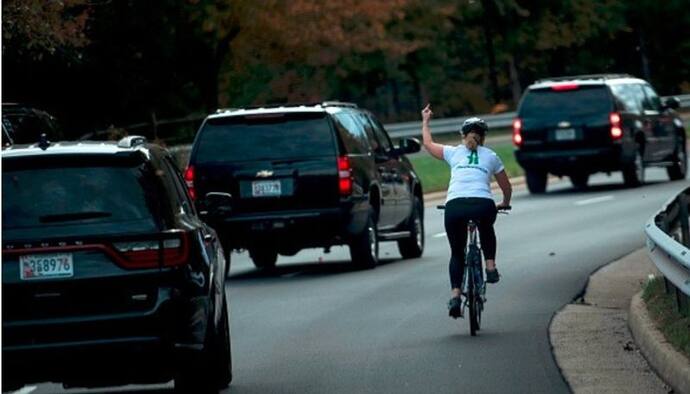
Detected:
[185,102,424,268]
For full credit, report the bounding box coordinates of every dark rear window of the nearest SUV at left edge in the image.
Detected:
[2,163,159,230]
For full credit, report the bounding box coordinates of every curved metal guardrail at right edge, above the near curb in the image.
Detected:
[645,187,690,314]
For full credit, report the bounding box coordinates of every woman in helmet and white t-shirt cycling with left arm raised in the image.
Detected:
[422,104,512,318]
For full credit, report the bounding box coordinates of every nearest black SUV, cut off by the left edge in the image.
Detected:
[2,137,232,392]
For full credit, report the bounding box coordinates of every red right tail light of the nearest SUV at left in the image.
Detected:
[113,232,189,268]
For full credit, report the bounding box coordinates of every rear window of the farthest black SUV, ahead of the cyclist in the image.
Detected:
[519,86,612,118]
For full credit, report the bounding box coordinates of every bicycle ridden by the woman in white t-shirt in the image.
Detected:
[436,205,511,336]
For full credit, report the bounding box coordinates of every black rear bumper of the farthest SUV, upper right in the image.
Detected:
[515,145,625,175]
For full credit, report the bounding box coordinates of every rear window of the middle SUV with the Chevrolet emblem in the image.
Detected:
[194,113,335,163]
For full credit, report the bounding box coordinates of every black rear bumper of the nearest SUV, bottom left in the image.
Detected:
[2,289,209,385]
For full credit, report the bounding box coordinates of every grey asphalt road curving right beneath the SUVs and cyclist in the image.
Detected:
[16,169,688,394]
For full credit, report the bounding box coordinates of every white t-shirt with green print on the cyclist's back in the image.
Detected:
[443,145,504,202]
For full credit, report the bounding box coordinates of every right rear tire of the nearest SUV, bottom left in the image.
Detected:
[175,295,232,393]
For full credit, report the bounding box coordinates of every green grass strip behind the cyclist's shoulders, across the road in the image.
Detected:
[410,142,523,193]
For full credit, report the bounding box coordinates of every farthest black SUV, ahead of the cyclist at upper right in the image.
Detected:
[513,74,687,193]
